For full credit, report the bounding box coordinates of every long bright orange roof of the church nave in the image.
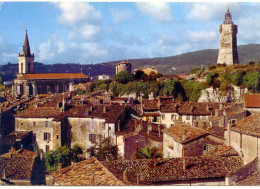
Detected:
[16,73,88,80]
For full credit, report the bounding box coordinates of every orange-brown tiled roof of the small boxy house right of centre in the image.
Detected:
[162,123,207,143]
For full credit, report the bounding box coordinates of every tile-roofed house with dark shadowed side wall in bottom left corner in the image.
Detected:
[0,148,45,185]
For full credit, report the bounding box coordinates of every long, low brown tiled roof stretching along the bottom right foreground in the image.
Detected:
[101,156,243,184]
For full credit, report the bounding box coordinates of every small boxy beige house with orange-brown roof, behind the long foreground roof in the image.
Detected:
[162,123,208,158]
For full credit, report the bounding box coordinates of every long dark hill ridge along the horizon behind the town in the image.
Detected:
[0,44,260,81]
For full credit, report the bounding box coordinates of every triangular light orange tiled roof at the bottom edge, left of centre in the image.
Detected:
[53,158,124,186]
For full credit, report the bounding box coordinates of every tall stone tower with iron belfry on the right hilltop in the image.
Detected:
[217,9,239,65]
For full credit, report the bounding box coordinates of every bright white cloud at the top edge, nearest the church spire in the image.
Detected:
[56,2,102,25]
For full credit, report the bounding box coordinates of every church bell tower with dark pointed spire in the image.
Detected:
[17,30,34,77]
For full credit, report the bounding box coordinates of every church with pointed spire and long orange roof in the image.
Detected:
[12,30,89,98]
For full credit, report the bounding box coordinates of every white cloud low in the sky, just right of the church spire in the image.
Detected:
[39,36,65,61]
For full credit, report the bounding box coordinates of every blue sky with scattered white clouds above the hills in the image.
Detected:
[0,1,260,64]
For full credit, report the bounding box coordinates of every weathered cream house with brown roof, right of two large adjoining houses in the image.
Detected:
[62,105,128,157]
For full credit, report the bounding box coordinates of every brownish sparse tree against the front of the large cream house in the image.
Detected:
[87,134,120,161]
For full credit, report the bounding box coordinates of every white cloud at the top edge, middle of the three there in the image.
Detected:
[136,2,172,22]
